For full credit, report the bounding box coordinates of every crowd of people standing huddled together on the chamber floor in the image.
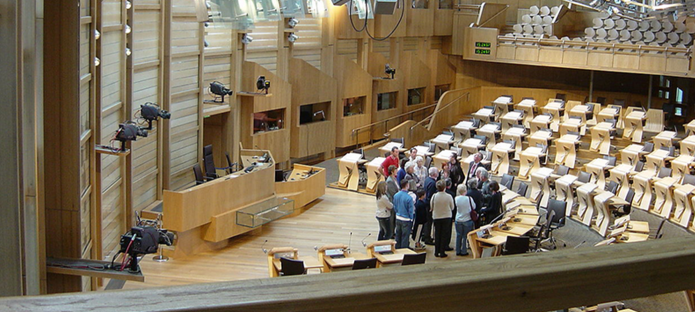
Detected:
[376,147,502,257]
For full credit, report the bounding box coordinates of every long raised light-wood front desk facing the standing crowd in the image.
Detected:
[162,149,282,257]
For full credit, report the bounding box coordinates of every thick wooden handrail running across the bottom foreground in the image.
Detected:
[0,236,695,312]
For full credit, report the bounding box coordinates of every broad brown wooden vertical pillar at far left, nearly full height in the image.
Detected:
[43,0,82,293]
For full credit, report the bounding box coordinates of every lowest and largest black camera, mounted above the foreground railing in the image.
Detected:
[118,226,174,273]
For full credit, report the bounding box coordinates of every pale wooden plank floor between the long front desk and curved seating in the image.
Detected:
[123,188,472,289]
